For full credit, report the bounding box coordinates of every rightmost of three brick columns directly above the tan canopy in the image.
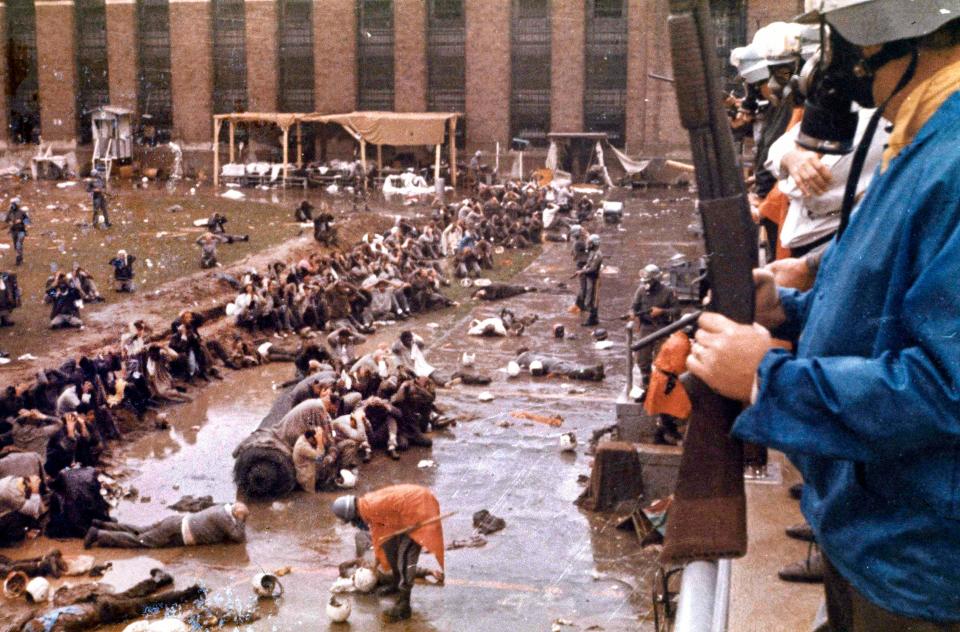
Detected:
[393,0,427,112]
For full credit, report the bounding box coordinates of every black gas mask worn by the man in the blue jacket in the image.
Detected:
[797,24,917,154]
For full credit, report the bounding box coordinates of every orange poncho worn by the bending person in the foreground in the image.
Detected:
[357,485,443,570]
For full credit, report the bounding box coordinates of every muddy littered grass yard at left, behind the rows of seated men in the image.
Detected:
[0,179,424,384]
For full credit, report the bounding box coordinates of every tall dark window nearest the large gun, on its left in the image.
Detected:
[583,0,627,147]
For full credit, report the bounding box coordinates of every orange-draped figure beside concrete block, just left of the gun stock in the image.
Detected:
[643,331,691,445]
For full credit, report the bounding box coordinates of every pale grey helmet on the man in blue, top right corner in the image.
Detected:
[800,0,960,46]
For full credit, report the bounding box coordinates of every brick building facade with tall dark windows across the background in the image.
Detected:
[0,0,803,163]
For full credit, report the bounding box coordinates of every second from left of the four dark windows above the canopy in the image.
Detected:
[279,0,322,112]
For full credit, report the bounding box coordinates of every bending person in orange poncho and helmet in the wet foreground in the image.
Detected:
[333,485,443,621]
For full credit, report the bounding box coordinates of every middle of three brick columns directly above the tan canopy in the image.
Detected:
[313,0,357,114]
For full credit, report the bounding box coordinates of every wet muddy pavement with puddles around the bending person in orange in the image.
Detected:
[0,192,699,631]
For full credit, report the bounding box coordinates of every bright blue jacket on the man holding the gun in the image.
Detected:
[733,92,960,622]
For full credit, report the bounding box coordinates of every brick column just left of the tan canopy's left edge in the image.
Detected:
[170,0,213,144]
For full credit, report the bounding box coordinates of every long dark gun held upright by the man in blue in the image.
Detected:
[662,0,757,564]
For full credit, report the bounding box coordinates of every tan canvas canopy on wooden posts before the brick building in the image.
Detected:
[213,112,460,185]
